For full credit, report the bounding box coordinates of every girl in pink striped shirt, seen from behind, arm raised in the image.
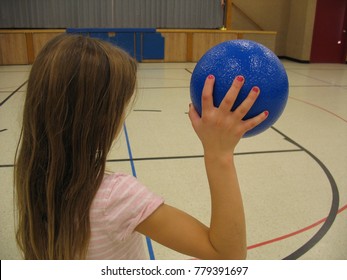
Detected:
[15,35,268,259]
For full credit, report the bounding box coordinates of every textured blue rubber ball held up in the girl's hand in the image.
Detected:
[190,40,288,137]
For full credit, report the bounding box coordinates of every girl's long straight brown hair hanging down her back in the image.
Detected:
[14,34,137,259]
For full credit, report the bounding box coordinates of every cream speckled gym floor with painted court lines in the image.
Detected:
[0,60,347,260]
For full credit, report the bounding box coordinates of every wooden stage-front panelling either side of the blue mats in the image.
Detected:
[0,29,276,65]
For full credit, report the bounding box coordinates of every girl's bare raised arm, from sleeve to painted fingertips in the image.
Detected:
[136,75,268,259]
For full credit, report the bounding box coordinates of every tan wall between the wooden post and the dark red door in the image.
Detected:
[232,0,317,61]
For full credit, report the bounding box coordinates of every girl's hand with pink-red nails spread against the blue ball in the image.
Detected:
[189,75,268,156]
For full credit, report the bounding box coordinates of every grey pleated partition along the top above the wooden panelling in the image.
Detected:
[0,0,223,28]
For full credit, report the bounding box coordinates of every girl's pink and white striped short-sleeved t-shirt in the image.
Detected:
[87,173,164,260]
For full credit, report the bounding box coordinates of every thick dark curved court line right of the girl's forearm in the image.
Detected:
[272,127,340,260]
